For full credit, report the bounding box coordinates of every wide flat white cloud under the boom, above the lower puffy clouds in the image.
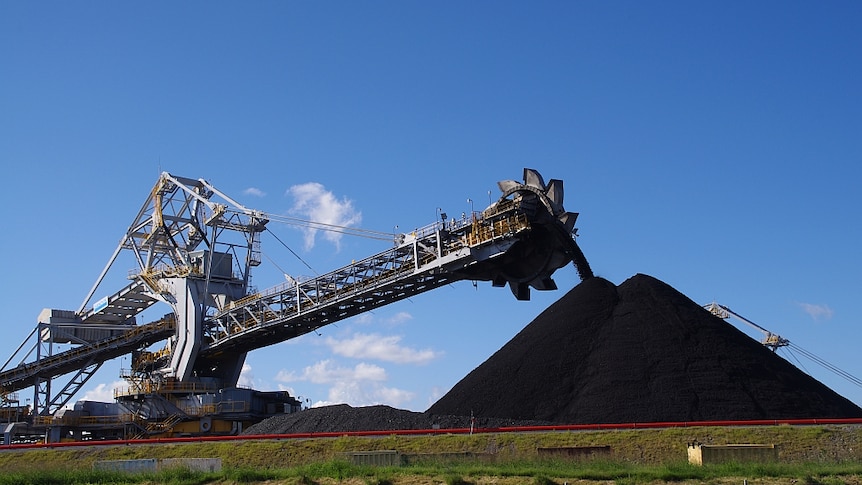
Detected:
[326,333,440,364]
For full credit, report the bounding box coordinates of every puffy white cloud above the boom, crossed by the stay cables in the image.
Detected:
[287,182,362,250]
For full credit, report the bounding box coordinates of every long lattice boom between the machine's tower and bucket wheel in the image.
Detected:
[201,208,530,356]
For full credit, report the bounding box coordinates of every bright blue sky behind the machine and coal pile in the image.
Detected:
[0,0,862,411]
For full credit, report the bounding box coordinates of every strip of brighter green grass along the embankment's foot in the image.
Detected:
[0,460,862,485]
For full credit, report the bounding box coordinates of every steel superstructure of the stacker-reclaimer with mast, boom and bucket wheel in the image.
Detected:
[0,169,592,416]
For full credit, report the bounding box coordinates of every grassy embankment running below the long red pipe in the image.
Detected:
[0,426,862,485]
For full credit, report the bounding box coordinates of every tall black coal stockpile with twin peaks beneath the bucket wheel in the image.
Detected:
[428,274,862,424]
